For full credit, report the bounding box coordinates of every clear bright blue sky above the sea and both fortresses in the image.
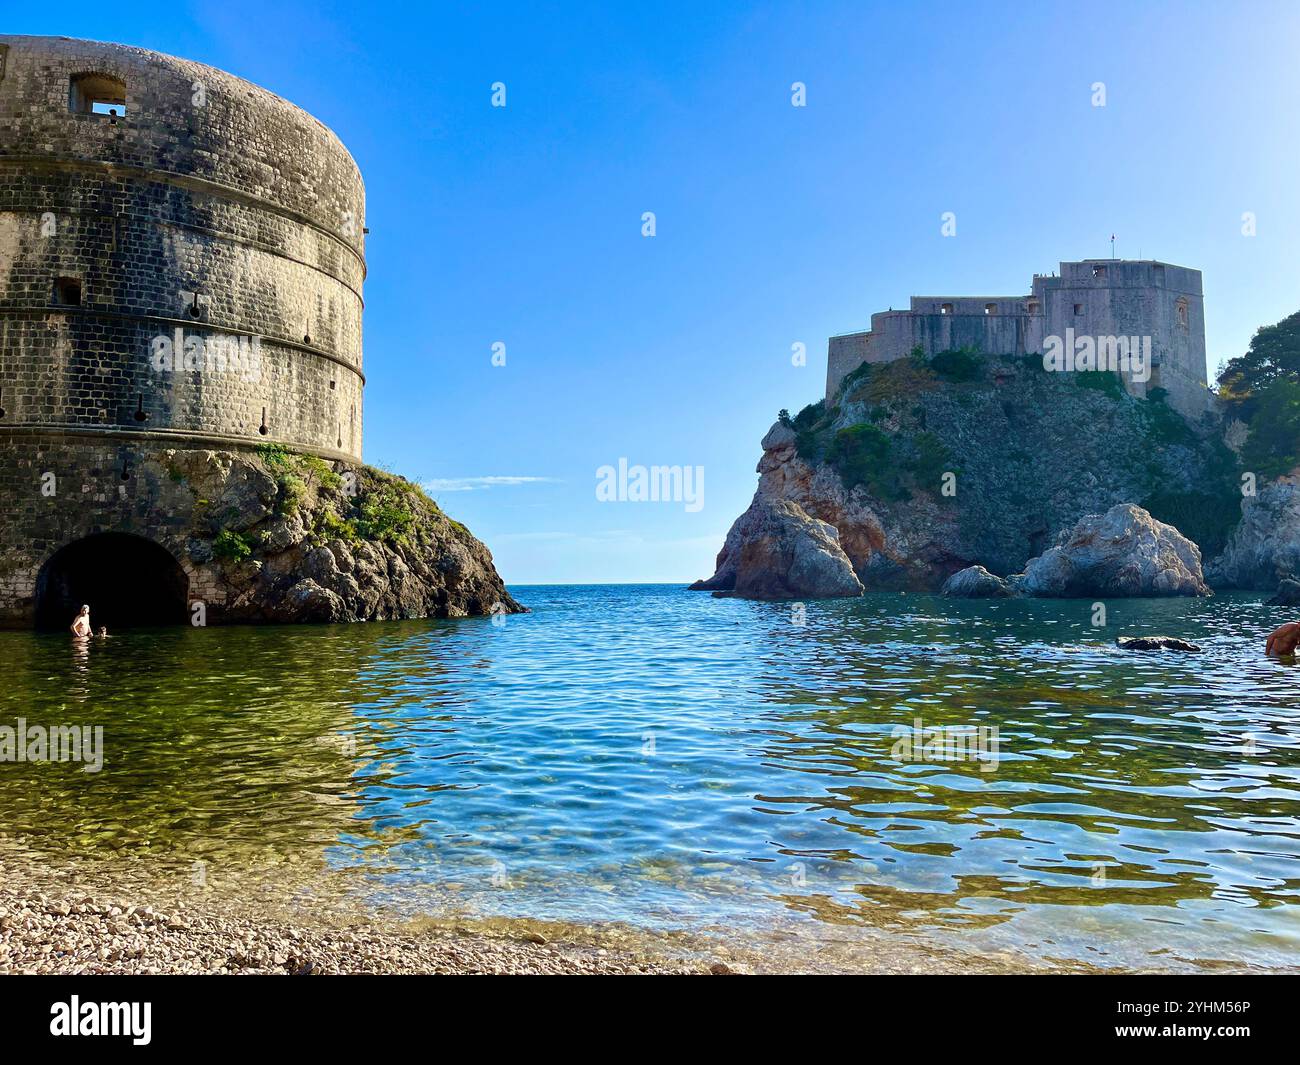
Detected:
[12,0,1300,583]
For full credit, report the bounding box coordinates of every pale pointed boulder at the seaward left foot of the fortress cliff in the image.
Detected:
[712,499,862,599]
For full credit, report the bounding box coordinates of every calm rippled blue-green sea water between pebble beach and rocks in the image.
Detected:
[0,586,1300,966]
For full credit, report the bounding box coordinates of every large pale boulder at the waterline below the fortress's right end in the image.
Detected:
[1019,503,1213,598]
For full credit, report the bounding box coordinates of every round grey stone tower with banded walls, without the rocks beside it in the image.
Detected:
[0,35,365,625]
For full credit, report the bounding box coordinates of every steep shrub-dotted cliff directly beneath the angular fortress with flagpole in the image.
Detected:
[697,352,1248,594]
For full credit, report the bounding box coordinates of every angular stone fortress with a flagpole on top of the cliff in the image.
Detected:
[826,259,1214,417]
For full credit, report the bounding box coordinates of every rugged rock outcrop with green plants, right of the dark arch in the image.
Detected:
[167,446,523,622]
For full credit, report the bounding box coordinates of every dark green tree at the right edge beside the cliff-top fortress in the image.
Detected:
[1218,311,1300,477]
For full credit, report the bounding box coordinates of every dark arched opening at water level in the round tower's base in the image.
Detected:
[36,533,190,633]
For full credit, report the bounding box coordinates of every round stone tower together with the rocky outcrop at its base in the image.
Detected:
[0,35,515,625]
